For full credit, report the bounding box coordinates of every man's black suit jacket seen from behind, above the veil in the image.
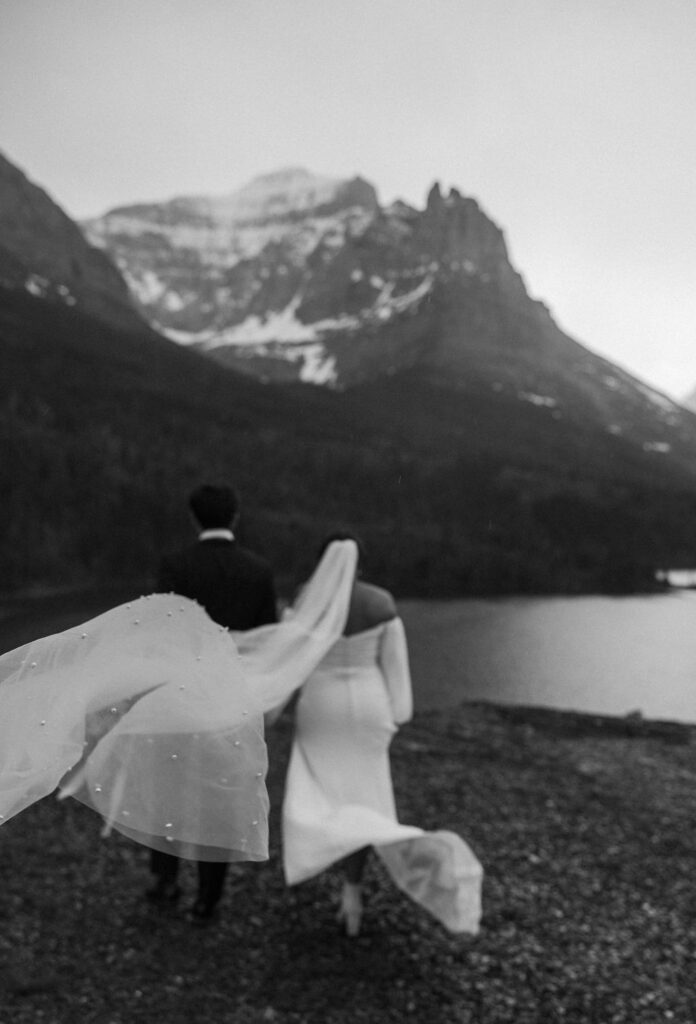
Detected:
[158,538,277,630]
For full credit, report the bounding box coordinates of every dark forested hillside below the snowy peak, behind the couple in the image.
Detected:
[0,289,696,595]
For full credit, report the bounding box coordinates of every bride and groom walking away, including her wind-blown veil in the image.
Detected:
[0,487,482,934]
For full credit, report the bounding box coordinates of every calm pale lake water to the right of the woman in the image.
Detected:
[399,591,696,722]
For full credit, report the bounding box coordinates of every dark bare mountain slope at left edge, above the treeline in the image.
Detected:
[0,154,145,329]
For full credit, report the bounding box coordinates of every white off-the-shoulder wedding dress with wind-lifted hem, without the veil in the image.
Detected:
[282,618,483,934]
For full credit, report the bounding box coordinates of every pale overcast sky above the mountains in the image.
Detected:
[0,0,696,397]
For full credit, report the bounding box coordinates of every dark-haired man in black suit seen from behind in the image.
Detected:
[146,484,277,924]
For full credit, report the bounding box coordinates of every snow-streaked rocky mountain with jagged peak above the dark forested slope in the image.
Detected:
[83,169,696,471]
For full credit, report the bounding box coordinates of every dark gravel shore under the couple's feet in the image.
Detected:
[0,705,696,1024]
